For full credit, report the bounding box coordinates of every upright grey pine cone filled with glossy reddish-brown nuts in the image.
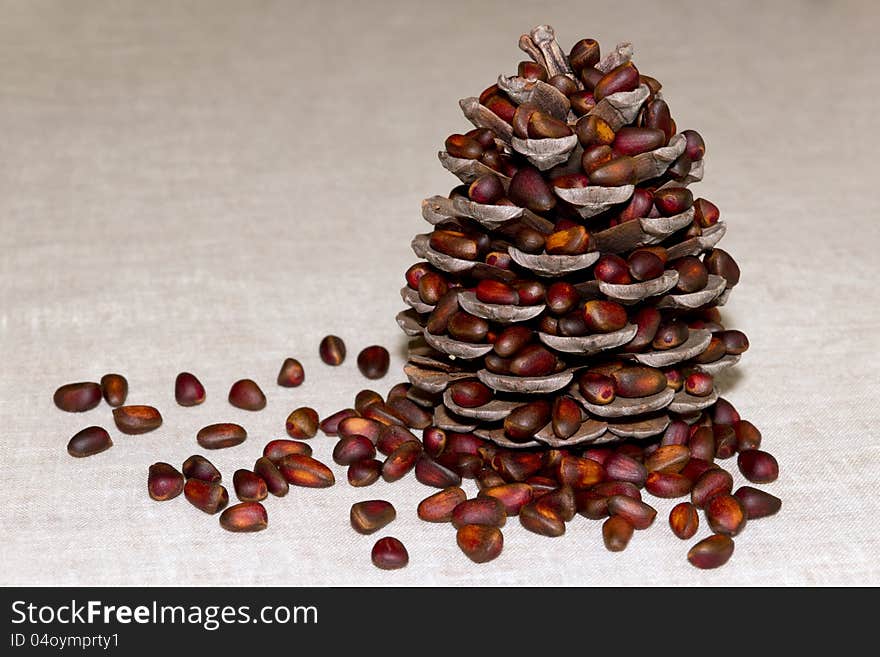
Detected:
[397,26,748,448]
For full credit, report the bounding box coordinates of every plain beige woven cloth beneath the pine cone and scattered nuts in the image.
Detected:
[0,0,880,586]
